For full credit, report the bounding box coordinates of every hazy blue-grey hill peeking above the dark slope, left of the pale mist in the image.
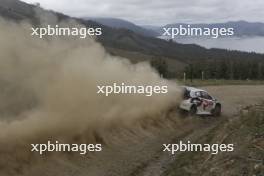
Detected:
[84,18,159,37]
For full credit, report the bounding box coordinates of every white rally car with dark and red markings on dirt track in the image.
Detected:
[180,87,222,116]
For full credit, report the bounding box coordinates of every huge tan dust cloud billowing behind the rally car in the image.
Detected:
[0,19,179,173]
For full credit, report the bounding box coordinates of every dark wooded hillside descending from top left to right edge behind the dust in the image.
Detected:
[0,0,264,79]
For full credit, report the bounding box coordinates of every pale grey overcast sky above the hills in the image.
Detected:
[20,0,264,25]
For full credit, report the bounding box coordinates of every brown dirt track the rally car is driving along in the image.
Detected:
[0,86,264,176]
